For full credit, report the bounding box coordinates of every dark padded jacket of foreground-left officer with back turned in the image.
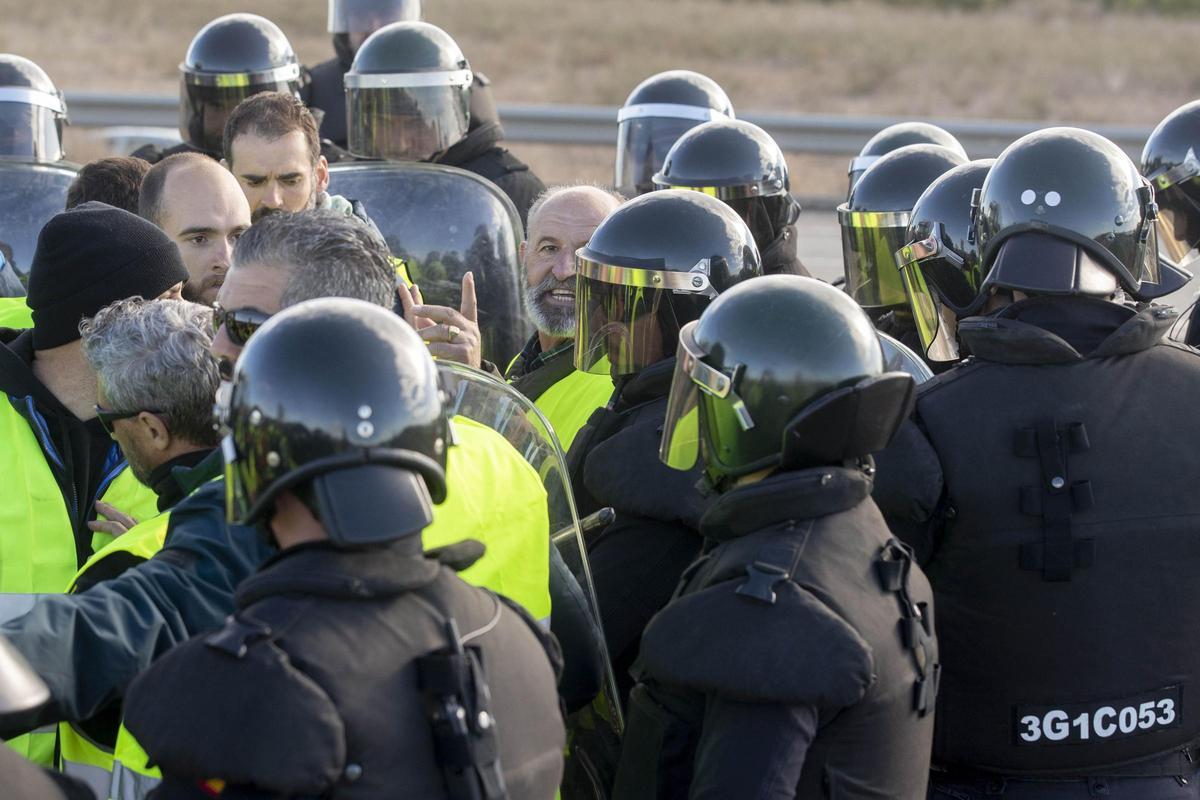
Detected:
[126,536,565,800]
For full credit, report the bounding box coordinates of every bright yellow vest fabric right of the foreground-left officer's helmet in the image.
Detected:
[421,416,550,620]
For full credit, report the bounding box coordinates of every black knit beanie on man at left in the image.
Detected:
[26,201,187,350]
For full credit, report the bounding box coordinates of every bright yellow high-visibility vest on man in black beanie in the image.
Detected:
[0,396,158,766]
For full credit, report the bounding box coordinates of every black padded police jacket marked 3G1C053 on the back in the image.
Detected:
[876,297,1200,782]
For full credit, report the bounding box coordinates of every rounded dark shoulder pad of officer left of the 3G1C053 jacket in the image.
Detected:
[641,578,875,709]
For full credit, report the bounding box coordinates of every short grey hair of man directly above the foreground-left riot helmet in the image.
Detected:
[233,209,396,308]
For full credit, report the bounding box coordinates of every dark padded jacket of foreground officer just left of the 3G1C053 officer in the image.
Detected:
[613,467,938,800]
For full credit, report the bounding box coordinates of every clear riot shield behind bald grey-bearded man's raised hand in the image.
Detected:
[329,162,533,365]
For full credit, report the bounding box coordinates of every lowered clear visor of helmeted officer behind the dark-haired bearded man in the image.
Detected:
[346,81,470,161]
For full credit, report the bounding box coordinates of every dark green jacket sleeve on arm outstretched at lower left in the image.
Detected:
[0,481,275,738]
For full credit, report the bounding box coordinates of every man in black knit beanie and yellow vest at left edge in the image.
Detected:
[0,203,187,764]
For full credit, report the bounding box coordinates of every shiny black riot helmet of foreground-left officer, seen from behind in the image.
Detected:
[216,297,448,546]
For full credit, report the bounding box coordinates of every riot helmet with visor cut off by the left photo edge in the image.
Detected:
[0,53,67,163]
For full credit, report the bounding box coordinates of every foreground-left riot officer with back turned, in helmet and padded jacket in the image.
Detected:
[127,299,564,800]
